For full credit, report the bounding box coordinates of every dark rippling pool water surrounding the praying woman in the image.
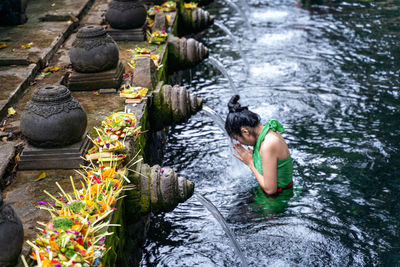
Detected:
[142,0,400,266]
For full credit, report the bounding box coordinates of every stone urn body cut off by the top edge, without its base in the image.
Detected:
[106,0,147,29]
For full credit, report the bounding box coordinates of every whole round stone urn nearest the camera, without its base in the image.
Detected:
[21,85,87,147]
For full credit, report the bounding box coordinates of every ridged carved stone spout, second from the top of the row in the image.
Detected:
[168,35,208,70]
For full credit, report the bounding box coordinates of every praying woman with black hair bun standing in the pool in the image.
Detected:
[225,95,293,197]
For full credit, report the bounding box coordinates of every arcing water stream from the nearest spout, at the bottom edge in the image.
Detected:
[194,193,249,267]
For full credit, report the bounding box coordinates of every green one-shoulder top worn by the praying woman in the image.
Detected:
[253,119,293,188]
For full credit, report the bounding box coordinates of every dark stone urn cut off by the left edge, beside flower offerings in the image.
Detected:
[0,194,24,267]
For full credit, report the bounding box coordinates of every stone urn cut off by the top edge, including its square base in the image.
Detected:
[106,0,147,42]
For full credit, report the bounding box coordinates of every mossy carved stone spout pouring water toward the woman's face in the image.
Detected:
[150,82,203,130]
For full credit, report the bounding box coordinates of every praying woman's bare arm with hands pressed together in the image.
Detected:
[233,144,278,194]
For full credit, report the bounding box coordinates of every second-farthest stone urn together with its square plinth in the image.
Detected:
[66,25,124,91]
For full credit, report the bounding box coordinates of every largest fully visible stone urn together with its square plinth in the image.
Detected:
[19,85,88,169]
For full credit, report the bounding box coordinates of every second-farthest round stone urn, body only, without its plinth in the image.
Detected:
[69,25,119,73]
